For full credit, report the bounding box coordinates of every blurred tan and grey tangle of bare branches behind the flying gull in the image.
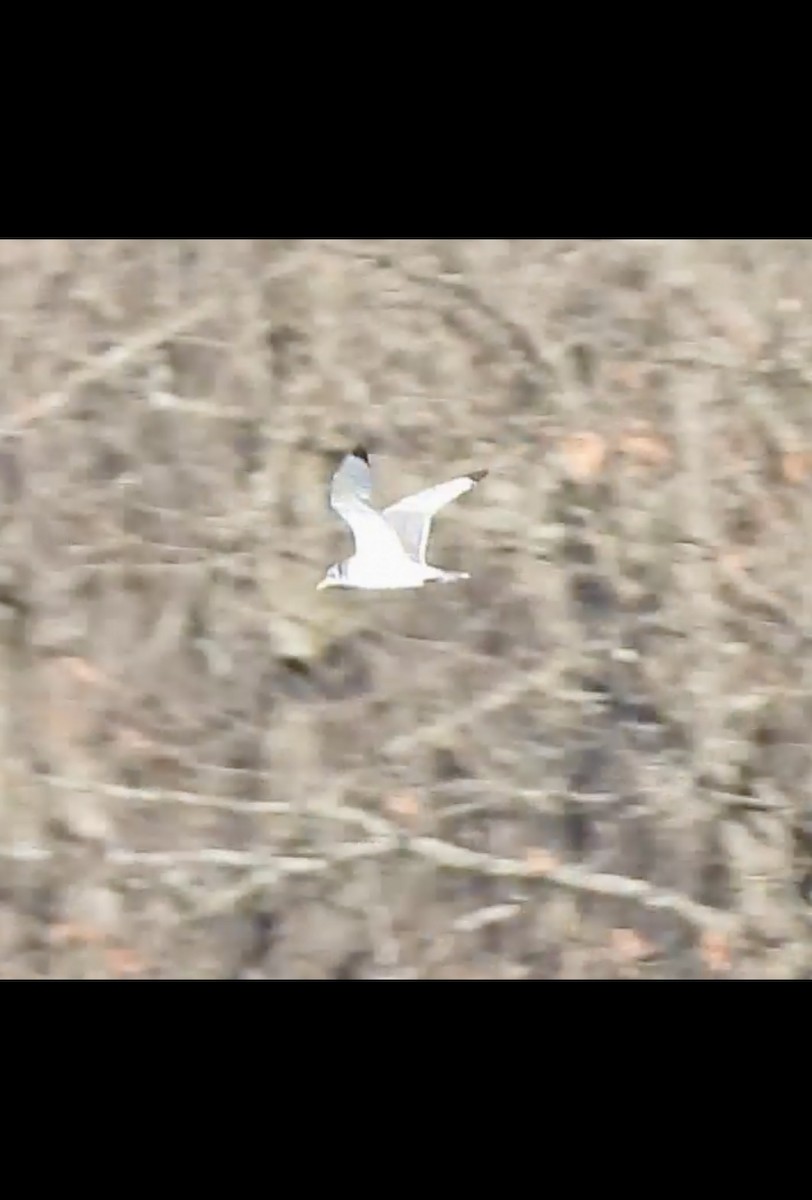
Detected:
[0,240,812,979]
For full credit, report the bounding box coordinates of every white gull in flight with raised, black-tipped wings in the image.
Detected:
[318,446,487,590]
